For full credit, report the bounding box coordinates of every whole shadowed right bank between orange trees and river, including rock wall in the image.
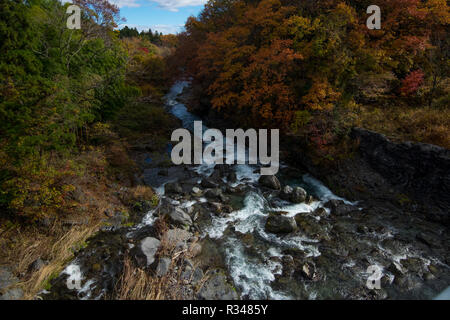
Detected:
[283,128,450,225]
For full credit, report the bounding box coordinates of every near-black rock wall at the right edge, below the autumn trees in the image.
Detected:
[351,128,450,219]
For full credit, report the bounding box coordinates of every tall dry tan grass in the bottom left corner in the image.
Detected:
[0,223,99,299]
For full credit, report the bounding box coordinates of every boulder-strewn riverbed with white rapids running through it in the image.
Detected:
[41,81,450,299]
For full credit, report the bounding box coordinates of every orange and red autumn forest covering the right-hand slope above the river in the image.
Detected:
[175,0,450,153]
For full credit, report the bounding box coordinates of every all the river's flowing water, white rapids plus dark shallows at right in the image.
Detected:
[57,81,449,299]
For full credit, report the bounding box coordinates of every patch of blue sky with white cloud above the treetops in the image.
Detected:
[109,0,207,34]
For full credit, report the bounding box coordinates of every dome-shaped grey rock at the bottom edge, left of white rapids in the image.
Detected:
[198,272,239,300]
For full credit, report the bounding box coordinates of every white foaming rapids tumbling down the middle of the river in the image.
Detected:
[150,81,356,299]
